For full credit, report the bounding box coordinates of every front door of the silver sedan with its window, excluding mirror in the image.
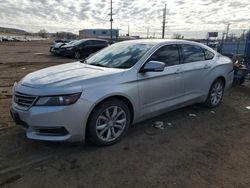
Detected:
[138,44,184,116]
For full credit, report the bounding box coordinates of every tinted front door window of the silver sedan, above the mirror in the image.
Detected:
[148,44,180,67]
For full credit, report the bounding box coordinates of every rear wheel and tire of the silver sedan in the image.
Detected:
[205,79,225,108]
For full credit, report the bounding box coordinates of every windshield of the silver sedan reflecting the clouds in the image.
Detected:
[84,43,153,69]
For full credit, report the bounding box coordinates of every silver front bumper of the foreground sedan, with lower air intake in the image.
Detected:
[11,99,92,142]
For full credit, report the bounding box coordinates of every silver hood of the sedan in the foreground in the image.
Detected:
[20,62,124,89]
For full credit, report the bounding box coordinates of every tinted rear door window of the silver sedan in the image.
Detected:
[181,44,205,63]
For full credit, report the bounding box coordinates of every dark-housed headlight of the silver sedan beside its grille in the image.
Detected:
[35,93,81,106]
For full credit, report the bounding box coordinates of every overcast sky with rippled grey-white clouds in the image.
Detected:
[0,0,250,37]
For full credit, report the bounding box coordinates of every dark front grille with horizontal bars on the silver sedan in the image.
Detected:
[14,92,37,109]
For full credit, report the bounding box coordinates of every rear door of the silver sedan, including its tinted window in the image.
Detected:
[180,44,213,100]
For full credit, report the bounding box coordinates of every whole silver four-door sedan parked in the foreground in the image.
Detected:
[11,40,233,145]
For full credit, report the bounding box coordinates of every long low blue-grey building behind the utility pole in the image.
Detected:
[79,29,119,39]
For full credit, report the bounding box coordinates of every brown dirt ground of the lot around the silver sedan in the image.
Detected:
[0,42,250,188]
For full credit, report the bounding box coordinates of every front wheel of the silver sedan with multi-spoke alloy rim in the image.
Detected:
[87,99,131,146]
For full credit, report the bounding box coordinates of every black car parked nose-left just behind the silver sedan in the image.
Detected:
[59,39,109,59]
